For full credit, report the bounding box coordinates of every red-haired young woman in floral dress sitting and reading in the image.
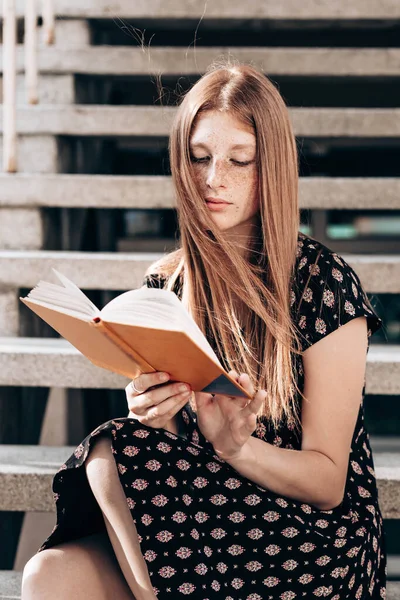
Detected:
[23,63,386,600]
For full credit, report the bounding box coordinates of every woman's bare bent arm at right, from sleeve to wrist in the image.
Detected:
[217,317,368,510]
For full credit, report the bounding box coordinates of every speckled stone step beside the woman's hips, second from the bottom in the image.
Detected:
[0,438,400,519]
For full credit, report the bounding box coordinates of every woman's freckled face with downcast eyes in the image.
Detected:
[190,111,259,233]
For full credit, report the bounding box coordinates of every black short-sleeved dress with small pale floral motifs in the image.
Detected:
[38,233,386,600]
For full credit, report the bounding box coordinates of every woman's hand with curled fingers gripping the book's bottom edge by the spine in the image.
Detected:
[125,371,192,428]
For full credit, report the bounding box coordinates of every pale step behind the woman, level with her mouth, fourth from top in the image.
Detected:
[0,173,400,210]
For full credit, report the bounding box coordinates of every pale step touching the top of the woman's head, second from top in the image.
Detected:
[0,45,400,77]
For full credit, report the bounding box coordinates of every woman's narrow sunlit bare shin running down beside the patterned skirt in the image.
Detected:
[85,436,157,600]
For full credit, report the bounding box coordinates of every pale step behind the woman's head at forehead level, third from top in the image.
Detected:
[0,104,400,138]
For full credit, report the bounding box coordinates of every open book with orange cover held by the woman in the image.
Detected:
[20,269,251,398]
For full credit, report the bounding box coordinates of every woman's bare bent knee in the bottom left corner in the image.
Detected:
[21,533,135,600]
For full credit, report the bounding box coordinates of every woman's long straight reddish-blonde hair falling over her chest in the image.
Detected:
[147,61,301,427]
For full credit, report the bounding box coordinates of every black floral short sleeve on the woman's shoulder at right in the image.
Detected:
[296,246,382,352]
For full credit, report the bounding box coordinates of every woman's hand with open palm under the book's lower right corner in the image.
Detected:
[194,370,266,460]
